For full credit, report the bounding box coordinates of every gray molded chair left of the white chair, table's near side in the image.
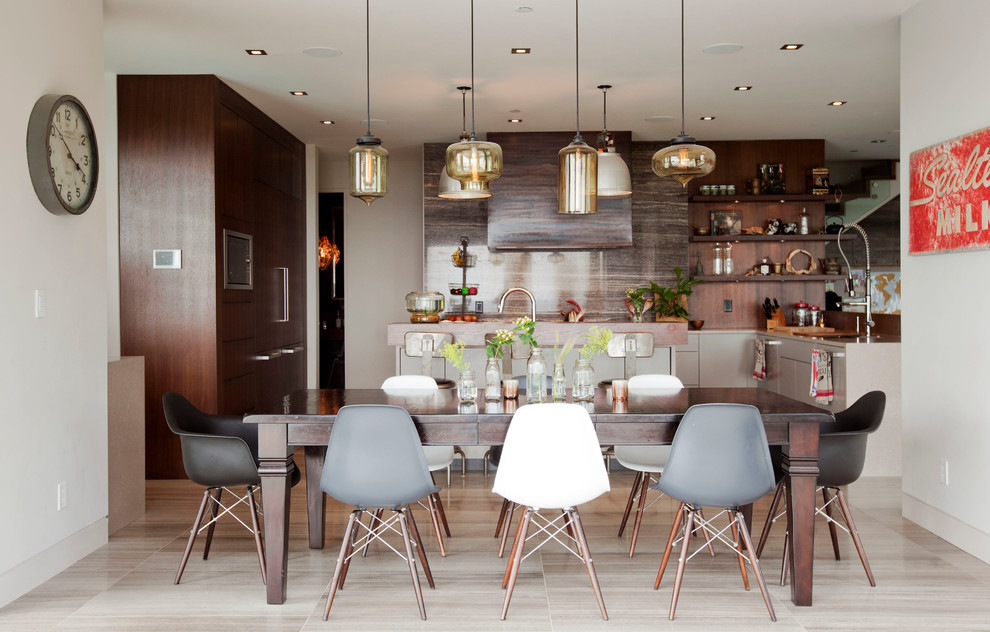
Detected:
[320,405,440,621]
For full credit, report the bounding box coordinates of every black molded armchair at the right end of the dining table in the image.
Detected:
[756,391,887,586]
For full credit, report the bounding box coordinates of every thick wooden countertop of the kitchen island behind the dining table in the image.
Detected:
[387,319,688,347]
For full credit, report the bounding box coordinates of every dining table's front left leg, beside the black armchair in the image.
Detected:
[258,424,296,604]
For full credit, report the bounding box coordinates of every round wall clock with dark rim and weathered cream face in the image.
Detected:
[27,94,100,215]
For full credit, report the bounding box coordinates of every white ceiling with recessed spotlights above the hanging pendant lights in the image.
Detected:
[103,0,917,160]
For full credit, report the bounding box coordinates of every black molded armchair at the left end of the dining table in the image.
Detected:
[162,393,300,584]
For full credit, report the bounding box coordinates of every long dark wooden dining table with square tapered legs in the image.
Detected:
[244,388,834,606]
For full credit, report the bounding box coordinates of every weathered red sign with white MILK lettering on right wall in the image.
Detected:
[908,127,990,255]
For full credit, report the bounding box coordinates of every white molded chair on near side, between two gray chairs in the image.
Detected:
[492,403,609,620]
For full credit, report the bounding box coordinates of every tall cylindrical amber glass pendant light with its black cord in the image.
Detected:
[557,0,598,215]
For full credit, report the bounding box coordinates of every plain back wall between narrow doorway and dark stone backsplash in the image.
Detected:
[320,156,423,388]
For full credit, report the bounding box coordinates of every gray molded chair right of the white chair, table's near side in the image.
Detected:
[651,404,777,621]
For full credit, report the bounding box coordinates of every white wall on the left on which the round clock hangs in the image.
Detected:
[0,0,108,605]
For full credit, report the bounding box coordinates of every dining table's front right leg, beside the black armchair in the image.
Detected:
[783,423,818,606]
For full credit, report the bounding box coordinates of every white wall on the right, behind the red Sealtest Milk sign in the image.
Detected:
[901,0,990,562]
